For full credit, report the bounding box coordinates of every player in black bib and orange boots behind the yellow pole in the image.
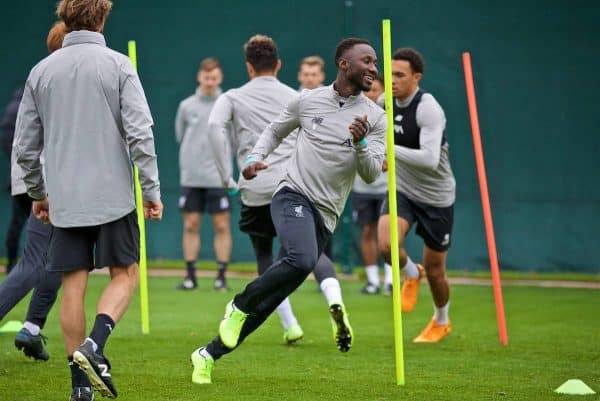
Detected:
[378,48,456,343]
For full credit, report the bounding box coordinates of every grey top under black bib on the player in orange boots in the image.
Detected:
[380,88,456,207]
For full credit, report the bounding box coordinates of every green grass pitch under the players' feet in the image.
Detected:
[0,276,600,401]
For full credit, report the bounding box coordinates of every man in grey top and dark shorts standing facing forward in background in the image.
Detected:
[175,58,231,290]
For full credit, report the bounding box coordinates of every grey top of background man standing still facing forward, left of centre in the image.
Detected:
[175,88,231,188]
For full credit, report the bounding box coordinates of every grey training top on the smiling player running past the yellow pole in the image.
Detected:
[251,85,387,232]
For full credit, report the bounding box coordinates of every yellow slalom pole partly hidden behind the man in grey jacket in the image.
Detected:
[127,40,150,334]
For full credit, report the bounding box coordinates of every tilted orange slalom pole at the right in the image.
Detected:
[463,52,508,345]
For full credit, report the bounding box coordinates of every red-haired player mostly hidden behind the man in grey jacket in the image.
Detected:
[0,21,66,361]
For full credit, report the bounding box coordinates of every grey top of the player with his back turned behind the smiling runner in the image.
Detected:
[208,76,297,206]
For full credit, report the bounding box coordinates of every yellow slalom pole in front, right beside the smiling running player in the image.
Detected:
[382,19,404,386]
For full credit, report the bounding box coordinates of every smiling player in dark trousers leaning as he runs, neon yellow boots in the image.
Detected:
[191,38,386,384]
